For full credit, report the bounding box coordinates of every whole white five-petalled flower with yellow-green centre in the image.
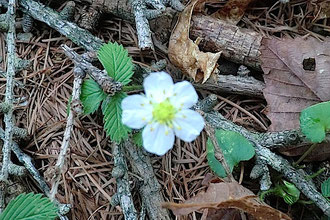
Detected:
[121,72,204,156]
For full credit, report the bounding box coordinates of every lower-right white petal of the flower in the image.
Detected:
[173,109,204,142]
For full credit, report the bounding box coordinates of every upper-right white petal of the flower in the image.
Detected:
[171,81,198,109]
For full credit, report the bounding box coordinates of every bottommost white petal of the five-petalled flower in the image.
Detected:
[142,123,174,156]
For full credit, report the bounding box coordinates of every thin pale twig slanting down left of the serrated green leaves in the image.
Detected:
[50,66,85,200]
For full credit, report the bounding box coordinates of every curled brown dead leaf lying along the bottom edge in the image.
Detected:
[164,182,291,220]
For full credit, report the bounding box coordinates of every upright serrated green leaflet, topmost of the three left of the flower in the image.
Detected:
[97,42,133,85]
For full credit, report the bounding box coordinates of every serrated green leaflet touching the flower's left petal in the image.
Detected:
[102,92,130,142]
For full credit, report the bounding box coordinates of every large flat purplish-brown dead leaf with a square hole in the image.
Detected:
[260,37,330,131]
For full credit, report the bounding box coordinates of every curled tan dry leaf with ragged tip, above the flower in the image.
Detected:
[168,0,221,83]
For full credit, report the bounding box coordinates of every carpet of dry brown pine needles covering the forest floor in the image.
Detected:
[0,0,330,220]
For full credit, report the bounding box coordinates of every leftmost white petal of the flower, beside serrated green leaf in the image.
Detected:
[121,95,152,129]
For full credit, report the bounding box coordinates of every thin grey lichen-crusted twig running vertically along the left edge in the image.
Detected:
[0,0,16,212]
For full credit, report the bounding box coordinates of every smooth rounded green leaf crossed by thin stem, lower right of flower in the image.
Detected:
[207,130,255,177]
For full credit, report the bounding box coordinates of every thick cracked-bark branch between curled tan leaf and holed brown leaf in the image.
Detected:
[190,15,262,70]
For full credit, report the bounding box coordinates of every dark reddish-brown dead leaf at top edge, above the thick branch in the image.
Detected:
[211,0,254,25]
